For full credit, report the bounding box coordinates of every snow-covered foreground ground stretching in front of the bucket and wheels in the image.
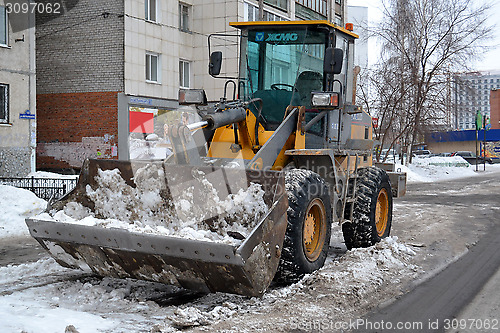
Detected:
[0,237,418,333]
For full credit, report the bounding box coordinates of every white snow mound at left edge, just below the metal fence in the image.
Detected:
[0,185,47,238]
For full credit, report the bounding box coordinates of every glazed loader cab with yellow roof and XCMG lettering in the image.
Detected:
[231,21,357,137]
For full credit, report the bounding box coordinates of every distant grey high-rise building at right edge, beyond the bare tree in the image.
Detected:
[454,71,500,130]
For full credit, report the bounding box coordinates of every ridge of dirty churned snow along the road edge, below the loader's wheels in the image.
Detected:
[150,237,419,332]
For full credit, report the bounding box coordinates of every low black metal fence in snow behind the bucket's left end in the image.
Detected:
[0,177,78,200]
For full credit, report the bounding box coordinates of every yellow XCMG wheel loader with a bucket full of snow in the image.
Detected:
[26,21,405,296]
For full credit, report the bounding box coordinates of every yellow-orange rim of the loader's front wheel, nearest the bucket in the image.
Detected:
[302,198,326,262]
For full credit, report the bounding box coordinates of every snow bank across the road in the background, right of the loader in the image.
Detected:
[396,156,476,183]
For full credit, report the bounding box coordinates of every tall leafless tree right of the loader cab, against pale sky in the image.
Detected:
[360,0,493,159]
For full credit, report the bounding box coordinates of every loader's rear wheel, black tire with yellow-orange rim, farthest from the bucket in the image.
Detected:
[342,167,392,250]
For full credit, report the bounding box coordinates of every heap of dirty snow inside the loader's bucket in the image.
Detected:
[37,165,268,245]
